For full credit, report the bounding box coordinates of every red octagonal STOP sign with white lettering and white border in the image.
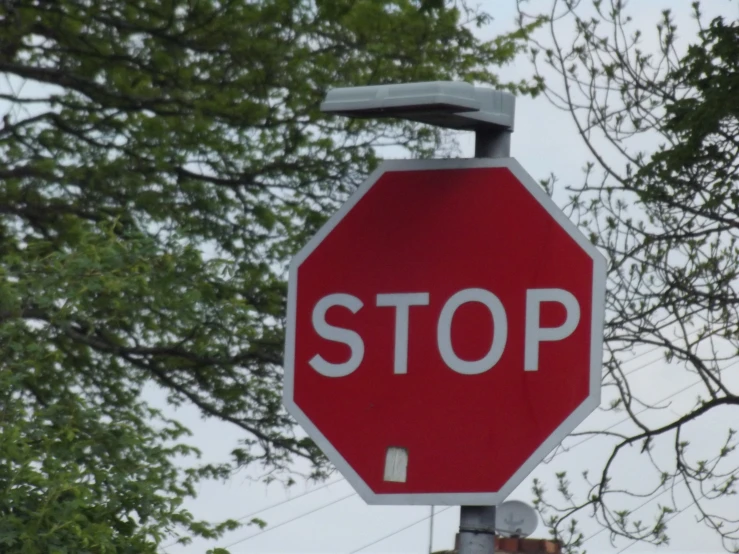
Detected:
[284,158,605,505]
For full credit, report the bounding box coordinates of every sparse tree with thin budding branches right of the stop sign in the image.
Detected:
[519,0,739,552]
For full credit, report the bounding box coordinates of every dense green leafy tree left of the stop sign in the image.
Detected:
[0,0,544,553]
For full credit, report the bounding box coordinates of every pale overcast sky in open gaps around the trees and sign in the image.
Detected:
[156,0,739,554]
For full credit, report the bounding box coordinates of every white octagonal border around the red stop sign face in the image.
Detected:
[283,158,606,506]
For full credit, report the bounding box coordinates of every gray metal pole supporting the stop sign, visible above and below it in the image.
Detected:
[459,122,511,554]
